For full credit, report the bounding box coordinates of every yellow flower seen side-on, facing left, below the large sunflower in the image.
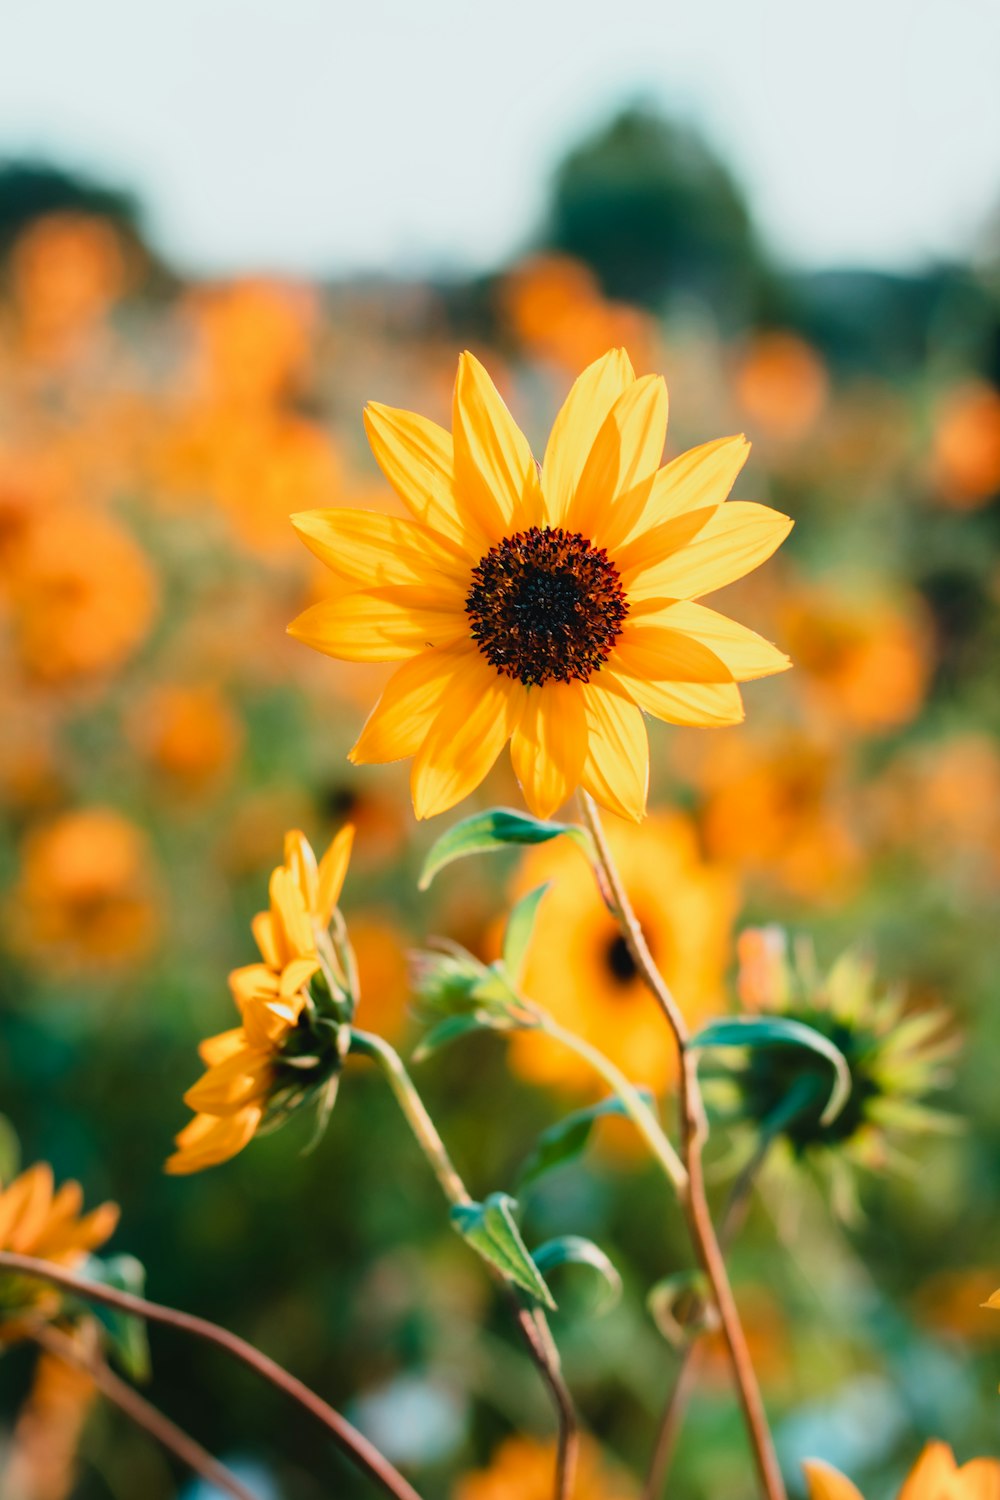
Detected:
[166,825,354,1175]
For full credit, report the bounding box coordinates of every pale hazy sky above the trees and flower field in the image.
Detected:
[0,0,1000,275]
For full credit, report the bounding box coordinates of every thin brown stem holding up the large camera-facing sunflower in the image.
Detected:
[580,792,786,1500]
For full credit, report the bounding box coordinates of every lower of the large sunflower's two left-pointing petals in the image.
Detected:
[288,587,468,662]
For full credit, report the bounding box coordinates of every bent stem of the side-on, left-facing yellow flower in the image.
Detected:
[351,1026,578,1500]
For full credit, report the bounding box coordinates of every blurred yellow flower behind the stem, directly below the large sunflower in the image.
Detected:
[511,813,736,1091]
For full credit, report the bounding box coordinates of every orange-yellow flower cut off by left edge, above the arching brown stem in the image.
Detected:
[0,1161,118,1322]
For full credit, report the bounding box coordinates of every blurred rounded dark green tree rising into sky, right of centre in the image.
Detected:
[546,105,765,317]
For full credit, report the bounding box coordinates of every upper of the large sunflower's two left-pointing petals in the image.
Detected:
[291,510,469,593]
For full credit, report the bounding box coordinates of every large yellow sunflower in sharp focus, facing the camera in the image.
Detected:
[289,350,792,821]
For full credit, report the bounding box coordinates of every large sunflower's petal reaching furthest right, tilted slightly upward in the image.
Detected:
[628,500,793,600]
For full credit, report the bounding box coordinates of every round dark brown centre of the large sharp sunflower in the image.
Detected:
[465,527,628,687]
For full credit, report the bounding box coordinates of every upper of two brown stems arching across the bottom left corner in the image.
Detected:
[0,1251,420,1500]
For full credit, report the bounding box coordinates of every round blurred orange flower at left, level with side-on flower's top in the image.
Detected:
[6,807,157,975]
